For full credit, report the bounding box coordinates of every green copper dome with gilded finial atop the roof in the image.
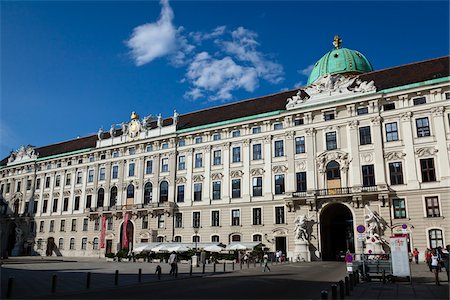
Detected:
[307,36,373,85]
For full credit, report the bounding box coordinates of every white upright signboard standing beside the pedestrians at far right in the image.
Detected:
[389,236,411,277]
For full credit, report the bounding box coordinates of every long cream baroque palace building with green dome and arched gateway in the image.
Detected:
[0,37,450,260]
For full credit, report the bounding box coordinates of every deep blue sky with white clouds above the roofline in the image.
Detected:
[0,0,449,158]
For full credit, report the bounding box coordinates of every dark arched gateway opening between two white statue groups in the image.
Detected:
[320,203,355,260]
